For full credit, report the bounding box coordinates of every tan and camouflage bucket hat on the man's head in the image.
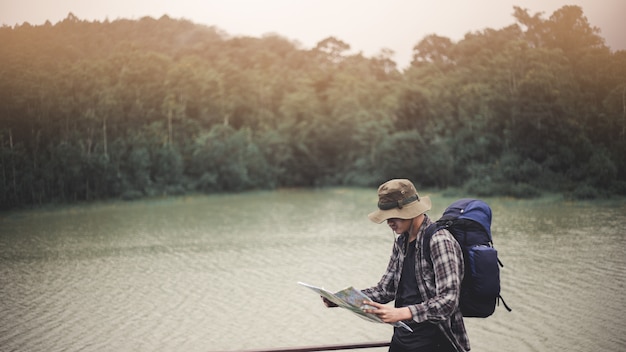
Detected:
[367,179,432,224]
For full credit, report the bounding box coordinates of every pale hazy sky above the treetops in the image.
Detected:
[0,0,626,68]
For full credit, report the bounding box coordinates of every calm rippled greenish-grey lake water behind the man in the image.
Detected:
[0,189,626,352]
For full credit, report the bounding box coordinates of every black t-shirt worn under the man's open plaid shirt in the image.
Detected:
[393,240,439,348]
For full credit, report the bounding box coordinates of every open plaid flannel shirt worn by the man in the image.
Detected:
[363,216,470,351]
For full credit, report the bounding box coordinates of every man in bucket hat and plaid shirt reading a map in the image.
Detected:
[363,179,470,352]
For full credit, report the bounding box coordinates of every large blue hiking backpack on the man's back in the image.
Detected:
[423,199,511,318]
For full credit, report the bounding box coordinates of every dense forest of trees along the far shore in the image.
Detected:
[0,6,626,209]
